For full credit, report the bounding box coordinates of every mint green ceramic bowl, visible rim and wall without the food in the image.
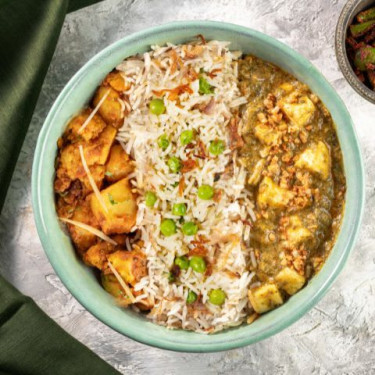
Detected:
[32,21,364,352]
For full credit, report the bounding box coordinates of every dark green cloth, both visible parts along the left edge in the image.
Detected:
[0,0,119,375]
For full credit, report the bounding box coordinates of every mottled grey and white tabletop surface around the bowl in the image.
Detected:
[0,0,375,375]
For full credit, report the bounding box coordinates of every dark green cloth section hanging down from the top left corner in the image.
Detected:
[0,0,99,212]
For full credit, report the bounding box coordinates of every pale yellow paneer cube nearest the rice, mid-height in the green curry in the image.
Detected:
[257,177,294,209]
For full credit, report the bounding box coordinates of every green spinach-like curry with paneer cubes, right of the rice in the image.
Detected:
[239,56,346,313]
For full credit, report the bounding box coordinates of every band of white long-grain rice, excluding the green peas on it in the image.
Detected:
[117,41,255,333]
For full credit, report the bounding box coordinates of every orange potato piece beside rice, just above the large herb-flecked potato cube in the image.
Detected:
[106,144,134,182]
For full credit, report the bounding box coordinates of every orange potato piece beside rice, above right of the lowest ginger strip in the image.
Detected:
[108,250,147,286]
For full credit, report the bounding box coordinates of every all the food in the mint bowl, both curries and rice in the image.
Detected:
[54,36,346,333]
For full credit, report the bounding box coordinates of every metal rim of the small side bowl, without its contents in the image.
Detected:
[335,0,375,104]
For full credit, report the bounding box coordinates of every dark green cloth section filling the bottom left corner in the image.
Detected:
[0,277,119,375]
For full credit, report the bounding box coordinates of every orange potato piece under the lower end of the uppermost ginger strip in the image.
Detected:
[65,108,106,142]
